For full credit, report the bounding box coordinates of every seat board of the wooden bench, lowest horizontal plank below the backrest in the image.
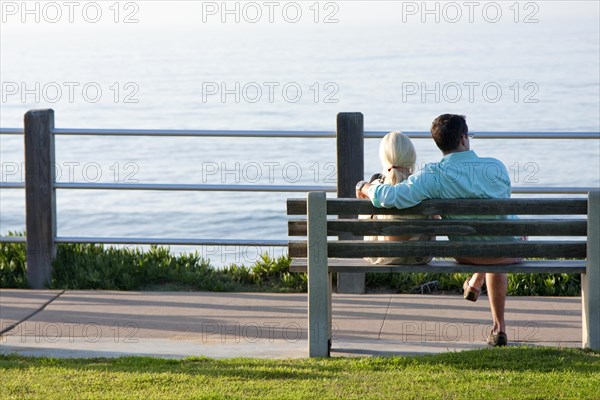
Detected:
[290,258,586,274]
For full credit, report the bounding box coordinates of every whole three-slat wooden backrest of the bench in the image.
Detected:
[287,192,588,259]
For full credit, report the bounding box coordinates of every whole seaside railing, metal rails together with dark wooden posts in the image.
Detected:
[0,110,600,287]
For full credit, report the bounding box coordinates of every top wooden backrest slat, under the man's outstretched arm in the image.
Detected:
[287,198,587,215]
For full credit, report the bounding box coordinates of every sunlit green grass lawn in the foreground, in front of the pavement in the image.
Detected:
[0,347,600,400]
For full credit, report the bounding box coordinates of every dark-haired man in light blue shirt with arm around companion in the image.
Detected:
[356,114,520,346]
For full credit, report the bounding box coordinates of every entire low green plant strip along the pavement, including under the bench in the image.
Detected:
[0,232,581,296]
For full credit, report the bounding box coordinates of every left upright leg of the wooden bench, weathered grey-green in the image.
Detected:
[308,192,331,357]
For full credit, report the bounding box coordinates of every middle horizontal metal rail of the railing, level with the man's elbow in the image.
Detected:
[0,182,598,194]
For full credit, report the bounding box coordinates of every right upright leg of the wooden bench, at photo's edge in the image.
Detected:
[581,190,600,350]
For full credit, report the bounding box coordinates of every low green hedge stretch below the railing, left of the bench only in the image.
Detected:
[0,236,307,292]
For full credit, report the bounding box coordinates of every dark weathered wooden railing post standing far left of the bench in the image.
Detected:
[25,110,56,289]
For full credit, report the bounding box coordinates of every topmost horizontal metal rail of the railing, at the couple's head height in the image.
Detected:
[0,128,600,139]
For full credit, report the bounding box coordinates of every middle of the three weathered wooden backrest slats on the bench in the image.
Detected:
[288,219,587,236]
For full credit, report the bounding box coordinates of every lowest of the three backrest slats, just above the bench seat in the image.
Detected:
[288,240,586,259]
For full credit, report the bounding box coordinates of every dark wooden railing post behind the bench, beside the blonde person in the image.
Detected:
[337,113,365,293]
